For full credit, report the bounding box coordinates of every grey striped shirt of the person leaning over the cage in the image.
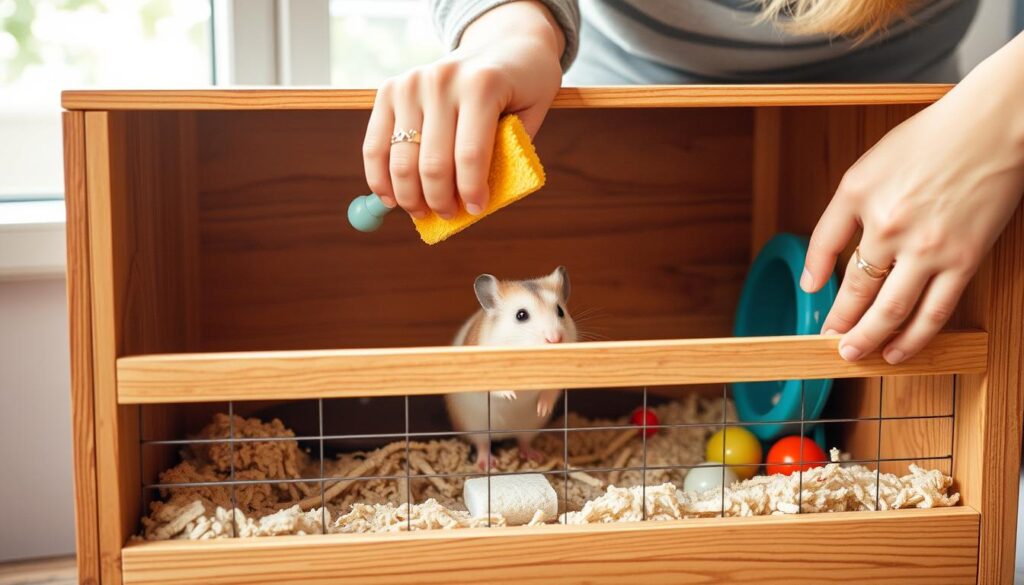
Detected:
[430,0,978,85]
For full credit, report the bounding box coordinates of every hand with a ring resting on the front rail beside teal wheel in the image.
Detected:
[801,51,1024,364]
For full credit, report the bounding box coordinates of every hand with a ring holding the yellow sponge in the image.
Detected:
[362,2,564,218]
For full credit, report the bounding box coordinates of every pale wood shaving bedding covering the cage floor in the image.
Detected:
[142,394,957,540]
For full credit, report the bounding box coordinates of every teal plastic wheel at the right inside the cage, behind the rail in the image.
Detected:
[731,234,839,449]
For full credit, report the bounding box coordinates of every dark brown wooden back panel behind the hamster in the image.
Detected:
[192,109,752,351]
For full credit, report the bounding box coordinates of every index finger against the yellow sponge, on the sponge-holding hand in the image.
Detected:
[455,99,501,215]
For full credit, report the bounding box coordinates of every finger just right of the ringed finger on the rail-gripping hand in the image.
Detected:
[839,262,931,362]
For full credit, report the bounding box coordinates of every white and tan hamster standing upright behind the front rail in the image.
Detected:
[444,266,577,468]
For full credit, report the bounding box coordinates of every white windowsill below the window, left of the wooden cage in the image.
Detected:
[0,201,67,281]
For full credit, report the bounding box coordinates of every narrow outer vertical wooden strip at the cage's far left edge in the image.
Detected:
[62,112,99,585]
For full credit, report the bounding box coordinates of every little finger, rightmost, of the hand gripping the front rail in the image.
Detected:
[882,270,970,364]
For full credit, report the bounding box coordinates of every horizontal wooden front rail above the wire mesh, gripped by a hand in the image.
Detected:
[117,331,988,404]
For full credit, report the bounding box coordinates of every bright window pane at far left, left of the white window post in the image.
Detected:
[0,0,213,201]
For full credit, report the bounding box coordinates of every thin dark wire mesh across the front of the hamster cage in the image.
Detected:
[138,376,957,537]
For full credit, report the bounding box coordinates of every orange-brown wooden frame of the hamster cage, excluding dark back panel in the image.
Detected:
[63,85,1024,584]
